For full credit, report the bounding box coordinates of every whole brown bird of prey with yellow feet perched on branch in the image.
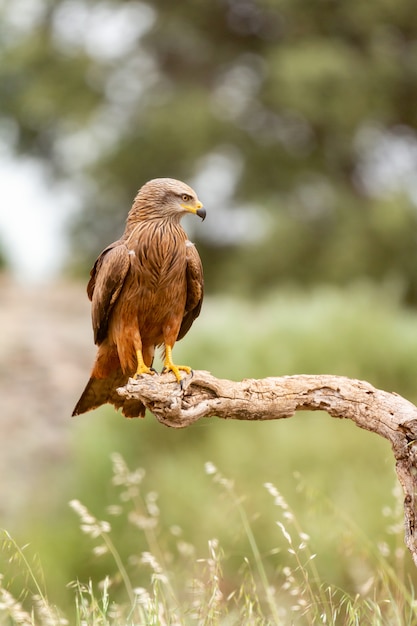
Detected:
[73,178,206,417]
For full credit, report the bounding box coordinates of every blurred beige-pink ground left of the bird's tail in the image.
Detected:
[0,276,94,525]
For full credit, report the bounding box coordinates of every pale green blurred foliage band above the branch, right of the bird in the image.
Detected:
[175,280,417,401]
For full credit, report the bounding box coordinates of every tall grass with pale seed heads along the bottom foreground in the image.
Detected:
[0,454,417,626]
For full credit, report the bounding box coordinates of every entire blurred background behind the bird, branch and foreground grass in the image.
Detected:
[0,0,417,616]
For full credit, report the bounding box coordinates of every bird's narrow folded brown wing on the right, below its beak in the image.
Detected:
[177,241,204,340]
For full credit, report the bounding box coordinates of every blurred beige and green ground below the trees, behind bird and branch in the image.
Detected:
[0,276,417,606]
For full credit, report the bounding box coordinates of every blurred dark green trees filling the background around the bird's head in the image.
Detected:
[0,0,417,301]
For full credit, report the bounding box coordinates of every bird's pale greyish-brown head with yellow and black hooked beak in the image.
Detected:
[128,178,206,222]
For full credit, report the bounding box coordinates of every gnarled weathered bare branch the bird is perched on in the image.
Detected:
[118,371,417,566]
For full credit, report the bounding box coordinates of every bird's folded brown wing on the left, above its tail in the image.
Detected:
[87,241,130,345]
